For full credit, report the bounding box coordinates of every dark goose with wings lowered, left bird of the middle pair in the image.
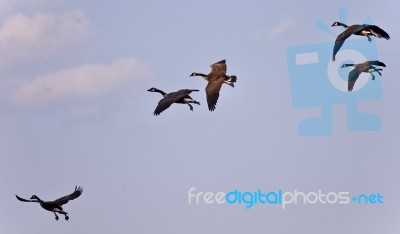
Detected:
[147,88,200,115]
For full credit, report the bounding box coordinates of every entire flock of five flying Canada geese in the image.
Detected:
[15,22,390,220]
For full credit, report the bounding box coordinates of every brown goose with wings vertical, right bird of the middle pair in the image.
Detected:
[190,59,237,111]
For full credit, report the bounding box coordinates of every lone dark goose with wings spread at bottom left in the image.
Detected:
[15,186,83,221]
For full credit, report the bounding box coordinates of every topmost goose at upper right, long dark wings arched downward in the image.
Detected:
[331,22,390,61]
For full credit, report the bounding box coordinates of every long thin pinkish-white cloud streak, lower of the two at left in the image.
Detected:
[13,58,150,108]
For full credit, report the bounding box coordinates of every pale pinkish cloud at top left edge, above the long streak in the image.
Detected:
[0,11,90,69]
